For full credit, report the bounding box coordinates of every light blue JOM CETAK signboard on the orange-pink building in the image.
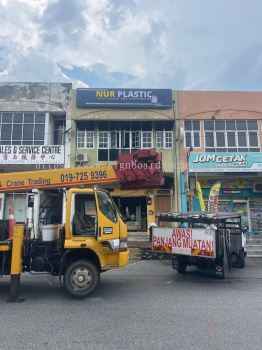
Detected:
[189,152,262,173]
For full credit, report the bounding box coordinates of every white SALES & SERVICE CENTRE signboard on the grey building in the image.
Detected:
[0,145,64,164]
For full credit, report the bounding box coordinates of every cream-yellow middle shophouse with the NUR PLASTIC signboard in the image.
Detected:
[70,89,175,232]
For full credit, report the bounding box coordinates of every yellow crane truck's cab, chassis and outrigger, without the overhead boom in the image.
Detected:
[0,188,128,299]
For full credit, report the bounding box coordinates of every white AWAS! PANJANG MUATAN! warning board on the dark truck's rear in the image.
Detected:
[152,227,216,258]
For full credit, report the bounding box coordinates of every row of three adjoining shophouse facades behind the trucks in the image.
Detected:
[0,83,262,232]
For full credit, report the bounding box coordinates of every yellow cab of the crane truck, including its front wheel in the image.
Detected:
[62,189,128,295]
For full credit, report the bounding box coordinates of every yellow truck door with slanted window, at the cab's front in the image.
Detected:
[96,191,119,241]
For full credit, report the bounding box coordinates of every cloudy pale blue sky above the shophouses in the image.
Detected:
[0,0,262,91]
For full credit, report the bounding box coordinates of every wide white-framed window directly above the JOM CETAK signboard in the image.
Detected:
[204,120,260,152]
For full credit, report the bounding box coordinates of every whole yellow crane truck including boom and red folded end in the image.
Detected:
[0,150,163,301]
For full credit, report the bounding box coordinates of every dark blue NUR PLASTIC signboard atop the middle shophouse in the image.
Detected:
[76,89,172,108]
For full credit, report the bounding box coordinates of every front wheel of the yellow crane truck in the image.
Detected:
[64,260,100,298]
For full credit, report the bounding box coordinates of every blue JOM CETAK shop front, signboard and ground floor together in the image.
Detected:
[188,152,262,232]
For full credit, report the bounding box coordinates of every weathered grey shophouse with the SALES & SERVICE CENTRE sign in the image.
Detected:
[0,83,71,223]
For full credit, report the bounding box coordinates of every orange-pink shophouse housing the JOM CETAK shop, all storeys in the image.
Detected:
[178,91,262,232]
